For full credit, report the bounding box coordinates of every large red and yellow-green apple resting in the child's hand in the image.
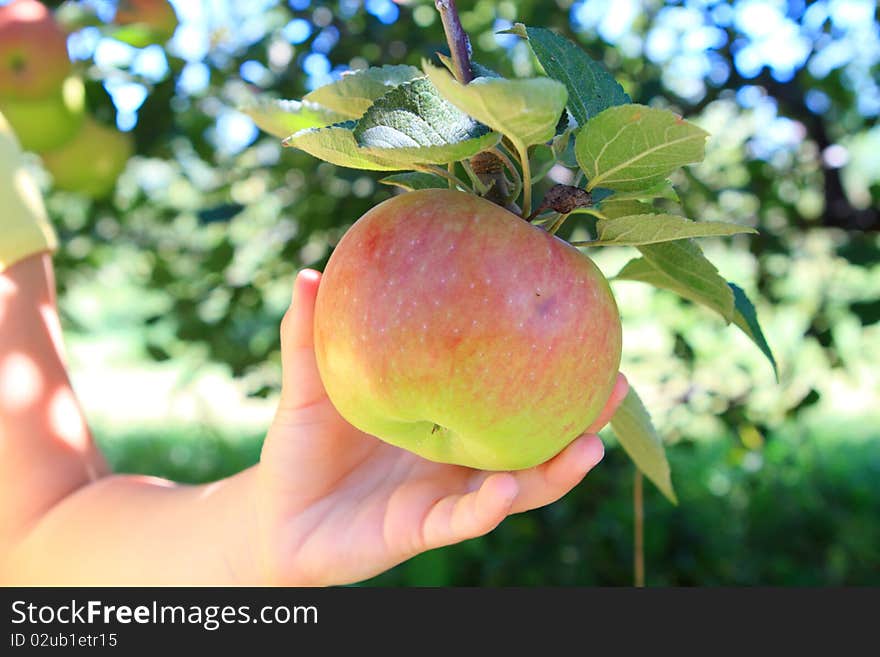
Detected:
[314,189,621,470]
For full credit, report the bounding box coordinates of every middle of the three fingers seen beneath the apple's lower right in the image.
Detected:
[502,434,605,513]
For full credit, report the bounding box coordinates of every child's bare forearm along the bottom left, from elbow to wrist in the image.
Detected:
[0,466,262,586]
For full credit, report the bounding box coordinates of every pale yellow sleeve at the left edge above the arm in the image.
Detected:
[0,109,58,271]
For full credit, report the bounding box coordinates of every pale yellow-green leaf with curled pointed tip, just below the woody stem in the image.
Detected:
[422,61,568,147]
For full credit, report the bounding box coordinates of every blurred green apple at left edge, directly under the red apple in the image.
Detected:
[0,76,86,153]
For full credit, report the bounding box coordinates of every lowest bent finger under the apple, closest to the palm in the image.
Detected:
[421,472,519,550]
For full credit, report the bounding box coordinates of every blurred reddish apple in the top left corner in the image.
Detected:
[0,0,71,99]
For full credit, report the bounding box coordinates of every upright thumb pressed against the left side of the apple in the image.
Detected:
[280,269,325,410]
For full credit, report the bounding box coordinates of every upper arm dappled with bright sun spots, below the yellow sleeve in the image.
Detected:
[0,254,108,558]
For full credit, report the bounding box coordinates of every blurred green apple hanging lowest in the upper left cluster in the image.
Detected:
[43,116,134,199]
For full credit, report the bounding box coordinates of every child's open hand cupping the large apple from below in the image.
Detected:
[256,270,627,585]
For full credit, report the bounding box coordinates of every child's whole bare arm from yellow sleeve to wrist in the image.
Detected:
[0,254,257,585]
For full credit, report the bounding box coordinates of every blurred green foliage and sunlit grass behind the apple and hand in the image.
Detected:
[0,0,880,586]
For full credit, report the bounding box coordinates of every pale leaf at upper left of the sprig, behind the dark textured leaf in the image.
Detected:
[303,65,424,119]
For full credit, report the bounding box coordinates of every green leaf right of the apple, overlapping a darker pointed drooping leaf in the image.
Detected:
[615,240,733,323]
